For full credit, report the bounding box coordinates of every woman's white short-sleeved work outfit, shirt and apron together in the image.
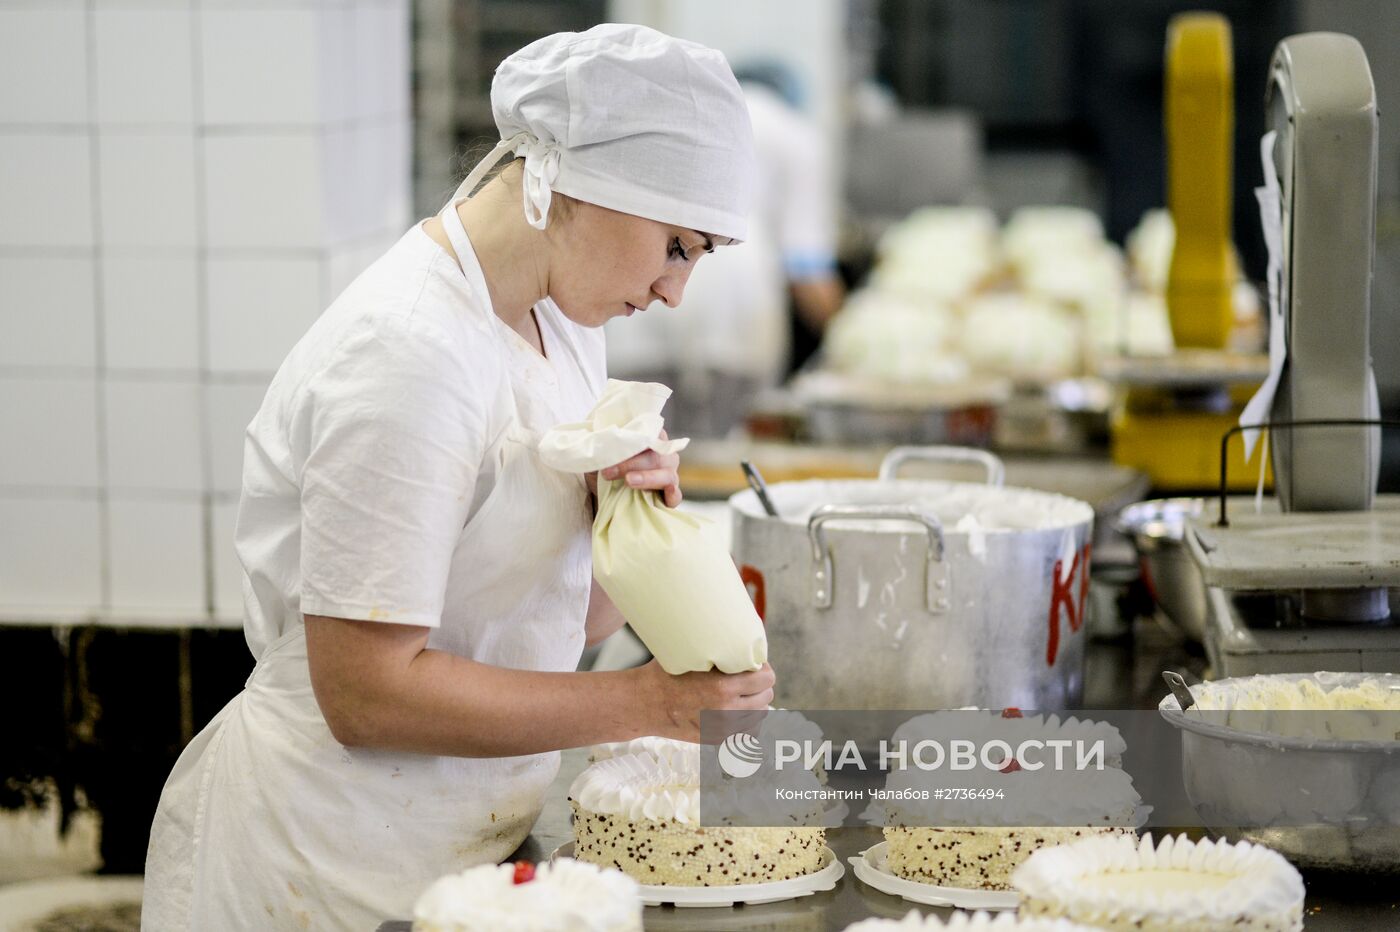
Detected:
[143,210,606,929]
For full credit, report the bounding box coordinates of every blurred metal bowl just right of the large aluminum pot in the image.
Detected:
[1113,498,1207,642]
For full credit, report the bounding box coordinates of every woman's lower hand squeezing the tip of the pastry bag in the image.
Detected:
[634,661,777,742]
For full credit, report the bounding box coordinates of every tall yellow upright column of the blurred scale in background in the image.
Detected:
[1165,13,1238,350]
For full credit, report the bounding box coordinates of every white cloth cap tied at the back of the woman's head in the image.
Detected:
[454,24,756,239]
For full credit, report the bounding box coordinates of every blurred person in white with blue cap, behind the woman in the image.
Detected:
[608,63,846,438]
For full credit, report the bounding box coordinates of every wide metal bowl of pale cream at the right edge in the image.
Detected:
[1158,673,1400,872]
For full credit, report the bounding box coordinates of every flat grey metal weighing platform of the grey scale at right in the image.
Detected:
[1186,495,1400,591]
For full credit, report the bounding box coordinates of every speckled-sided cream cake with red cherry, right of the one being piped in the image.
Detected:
[864,709,1145,890]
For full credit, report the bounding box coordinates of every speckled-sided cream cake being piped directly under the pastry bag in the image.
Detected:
[568,746,826,887]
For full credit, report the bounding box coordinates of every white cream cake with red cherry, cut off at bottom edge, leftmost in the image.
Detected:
[413,858,643,932]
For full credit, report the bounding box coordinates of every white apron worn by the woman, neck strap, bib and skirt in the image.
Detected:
[141,203,602,931]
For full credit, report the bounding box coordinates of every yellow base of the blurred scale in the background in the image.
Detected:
[1112,385,1274,493]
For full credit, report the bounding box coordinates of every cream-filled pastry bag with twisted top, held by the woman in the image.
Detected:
[539,379,769,673]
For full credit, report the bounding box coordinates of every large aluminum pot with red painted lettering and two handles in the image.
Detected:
[729,448,1093,711]
